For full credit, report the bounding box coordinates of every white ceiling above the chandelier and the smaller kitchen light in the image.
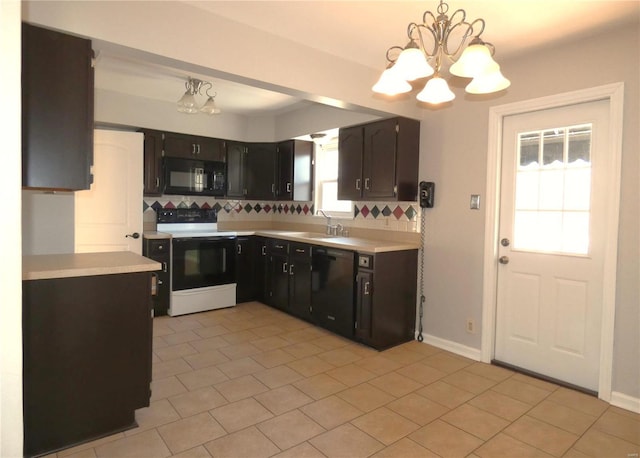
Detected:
[96,0,640,115]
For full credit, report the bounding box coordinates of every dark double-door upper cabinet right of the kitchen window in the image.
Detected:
[338,118,420,201]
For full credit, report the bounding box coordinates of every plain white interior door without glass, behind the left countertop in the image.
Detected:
[75,130,144,254]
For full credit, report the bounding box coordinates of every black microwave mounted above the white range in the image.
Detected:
[163,157,227,196]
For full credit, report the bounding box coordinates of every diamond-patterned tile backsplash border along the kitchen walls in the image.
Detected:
[142,196,419,221]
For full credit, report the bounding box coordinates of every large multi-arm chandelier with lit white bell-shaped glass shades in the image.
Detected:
[371,0,511,105]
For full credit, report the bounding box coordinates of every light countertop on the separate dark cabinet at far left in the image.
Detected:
[22,251,162,280]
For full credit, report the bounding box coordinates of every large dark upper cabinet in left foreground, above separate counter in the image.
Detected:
[22,23,94,191]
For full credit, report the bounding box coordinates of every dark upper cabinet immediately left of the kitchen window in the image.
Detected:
[276,140,313,202]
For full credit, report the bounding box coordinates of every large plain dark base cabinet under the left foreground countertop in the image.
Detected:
[22,272,153,456]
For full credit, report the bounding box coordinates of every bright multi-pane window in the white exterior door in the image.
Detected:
[513,124,591,254]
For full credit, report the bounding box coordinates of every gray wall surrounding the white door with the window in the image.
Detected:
[420,24,640,398]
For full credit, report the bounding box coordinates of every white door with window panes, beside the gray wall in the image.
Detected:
[495,100,614,391]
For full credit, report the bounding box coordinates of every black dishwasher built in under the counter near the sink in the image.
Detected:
[311,246,355,338]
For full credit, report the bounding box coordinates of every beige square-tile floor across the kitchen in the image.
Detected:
[53,302,640,458]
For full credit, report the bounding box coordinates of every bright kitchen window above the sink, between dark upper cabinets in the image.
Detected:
[314,133,353,218]
